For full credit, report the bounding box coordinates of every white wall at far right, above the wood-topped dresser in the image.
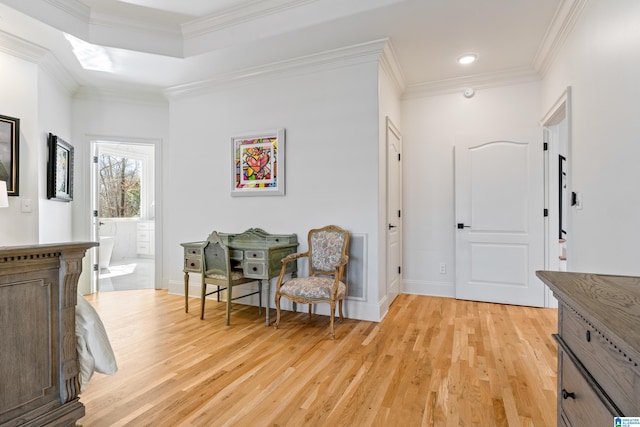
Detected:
[541,0,640,275]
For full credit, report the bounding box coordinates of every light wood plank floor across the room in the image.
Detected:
[80,290,557,427]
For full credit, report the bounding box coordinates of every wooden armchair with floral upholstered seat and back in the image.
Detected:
[275,225,349,339]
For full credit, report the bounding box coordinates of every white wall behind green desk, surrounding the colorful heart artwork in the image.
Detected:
[164,60,380,320]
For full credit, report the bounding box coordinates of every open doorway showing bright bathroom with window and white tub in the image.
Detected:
[92,140,156,292]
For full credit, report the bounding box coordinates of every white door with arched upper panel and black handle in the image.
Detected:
[455,128,544,307]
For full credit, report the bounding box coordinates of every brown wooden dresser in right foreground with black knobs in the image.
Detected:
[537,271,640,427]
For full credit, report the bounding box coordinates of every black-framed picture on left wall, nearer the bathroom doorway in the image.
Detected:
[47,133,73,202]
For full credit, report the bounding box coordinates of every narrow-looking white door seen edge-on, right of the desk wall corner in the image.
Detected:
[387,118,402,304]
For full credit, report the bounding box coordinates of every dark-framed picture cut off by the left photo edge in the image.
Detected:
[0,116,20,196]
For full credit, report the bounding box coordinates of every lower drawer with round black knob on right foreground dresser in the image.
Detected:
[558,350,615,427]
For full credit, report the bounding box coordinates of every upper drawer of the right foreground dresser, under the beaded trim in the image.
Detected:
[560,306,640,416]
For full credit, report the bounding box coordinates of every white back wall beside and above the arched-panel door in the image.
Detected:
[400,83,541,296]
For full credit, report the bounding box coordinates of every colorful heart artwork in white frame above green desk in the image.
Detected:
[231,129,285,196]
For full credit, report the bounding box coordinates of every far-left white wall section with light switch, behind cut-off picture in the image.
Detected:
[0,52,42,246]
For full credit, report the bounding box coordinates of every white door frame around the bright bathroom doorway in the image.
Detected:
[84,134,162,293]
